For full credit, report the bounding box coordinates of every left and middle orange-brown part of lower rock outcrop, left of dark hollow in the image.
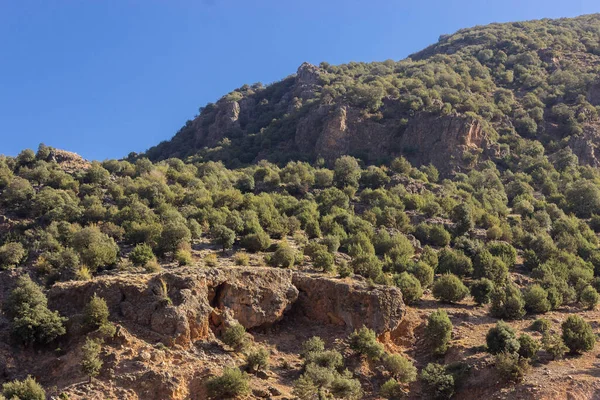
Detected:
[48,268,298,346]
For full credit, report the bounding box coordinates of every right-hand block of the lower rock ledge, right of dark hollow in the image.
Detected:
[293,273,406,335]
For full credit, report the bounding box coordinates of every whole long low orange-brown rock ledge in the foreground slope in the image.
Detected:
[48,267,405,347]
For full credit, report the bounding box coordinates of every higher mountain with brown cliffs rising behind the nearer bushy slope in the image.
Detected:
[146,14,600,172]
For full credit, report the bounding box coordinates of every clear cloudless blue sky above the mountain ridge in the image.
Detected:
[0,0,600,160]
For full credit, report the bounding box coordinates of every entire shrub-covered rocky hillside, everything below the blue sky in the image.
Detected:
[0,15,600,400]
